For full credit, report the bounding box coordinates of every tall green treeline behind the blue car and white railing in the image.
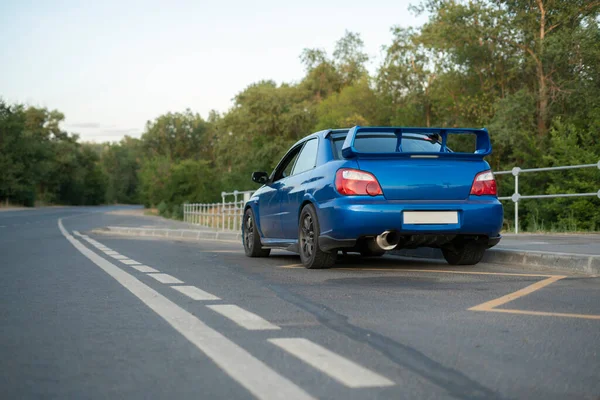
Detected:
[0,0,600,230]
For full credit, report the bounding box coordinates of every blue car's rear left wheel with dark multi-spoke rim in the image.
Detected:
[298,204,337,269]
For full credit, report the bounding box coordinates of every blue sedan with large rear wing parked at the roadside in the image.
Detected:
[242,126,503,268]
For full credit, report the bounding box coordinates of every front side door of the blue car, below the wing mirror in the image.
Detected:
[258,145,302,239]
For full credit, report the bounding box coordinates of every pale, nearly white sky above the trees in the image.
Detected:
[0,0,426,142]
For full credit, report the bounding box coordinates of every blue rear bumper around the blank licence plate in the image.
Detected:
[317,196,504,249]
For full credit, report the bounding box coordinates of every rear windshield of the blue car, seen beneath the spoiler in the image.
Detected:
[333,132,442,159]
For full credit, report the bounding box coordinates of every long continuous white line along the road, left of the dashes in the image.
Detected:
[58,219,314,400]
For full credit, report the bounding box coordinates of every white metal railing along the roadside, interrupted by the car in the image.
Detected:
[183,161,600,233]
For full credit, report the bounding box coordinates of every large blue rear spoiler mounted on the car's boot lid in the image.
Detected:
[342,126,492,160]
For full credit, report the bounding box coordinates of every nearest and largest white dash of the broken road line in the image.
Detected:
[268,338,395,388]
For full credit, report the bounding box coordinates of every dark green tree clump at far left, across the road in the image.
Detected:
[0,101,105,206]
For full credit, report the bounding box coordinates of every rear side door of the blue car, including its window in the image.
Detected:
[279,138,319,239]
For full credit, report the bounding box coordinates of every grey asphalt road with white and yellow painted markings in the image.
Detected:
[0,208,600,400]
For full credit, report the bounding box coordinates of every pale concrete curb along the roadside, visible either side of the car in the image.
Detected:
[93,226,600,275]
